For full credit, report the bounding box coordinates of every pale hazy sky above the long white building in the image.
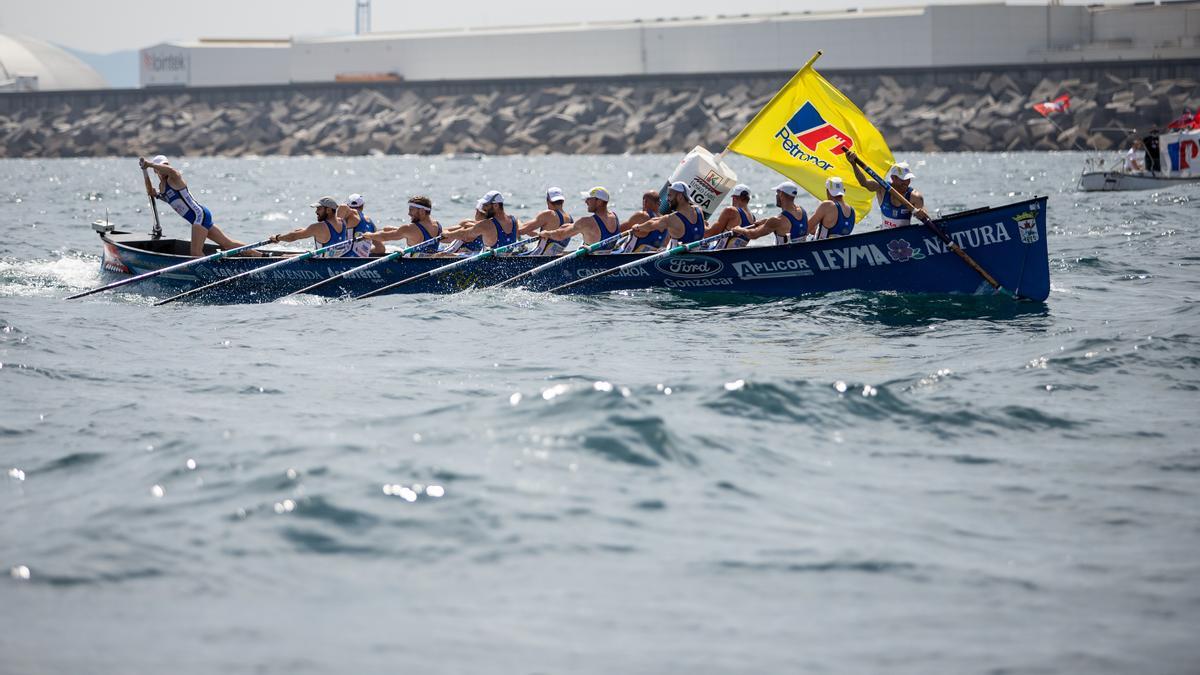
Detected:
[0,0,1123,54]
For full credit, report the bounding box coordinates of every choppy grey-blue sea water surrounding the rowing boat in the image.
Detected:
[0,154,1200,674]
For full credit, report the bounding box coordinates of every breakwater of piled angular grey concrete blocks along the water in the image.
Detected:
[0,62,1200,157]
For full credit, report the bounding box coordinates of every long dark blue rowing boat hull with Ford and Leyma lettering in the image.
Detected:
[101,197,1050,303]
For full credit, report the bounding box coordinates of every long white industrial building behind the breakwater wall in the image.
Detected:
[142,1,1200,86]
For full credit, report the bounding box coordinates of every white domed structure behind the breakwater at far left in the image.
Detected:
[0,35,108,91]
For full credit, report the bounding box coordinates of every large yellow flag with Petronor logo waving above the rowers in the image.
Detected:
[728,52,895,221]
